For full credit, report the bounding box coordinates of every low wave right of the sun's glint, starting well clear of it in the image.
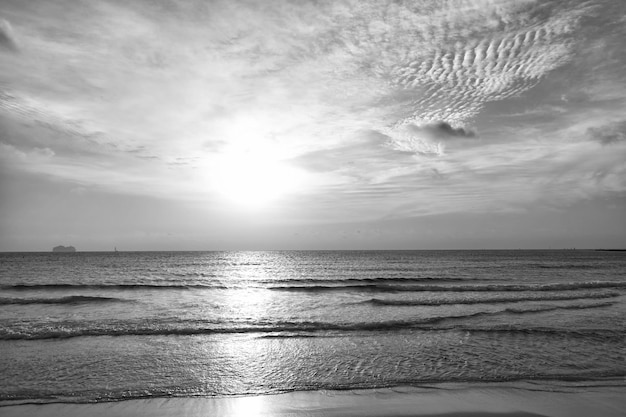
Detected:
[366,292,621,307]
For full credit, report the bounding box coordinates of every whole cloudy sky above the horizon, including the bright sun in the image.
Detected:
[0,0,626,251]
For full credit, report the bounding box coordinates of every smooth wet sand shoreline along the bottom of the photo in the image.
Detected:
[0,379,626,417]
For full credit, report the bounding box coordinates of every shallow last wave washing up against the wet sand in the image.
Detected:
[0,369,626,404]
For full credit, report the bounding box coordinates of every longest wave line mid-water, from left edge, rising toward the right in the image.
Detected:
[0,302,614,340]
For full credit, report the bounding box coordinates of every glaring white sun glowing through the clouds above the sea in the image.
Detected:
[212,150,303,209]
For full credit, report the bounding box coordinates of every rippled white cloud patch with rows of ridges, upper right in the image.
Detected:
[378,2,588,127]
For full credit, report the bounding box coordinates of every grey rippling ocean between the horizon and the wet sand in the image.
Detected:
[0,250,626,405]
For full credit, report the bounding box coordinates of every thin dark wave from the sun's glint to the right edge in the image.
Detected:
[269,281,626,292]
